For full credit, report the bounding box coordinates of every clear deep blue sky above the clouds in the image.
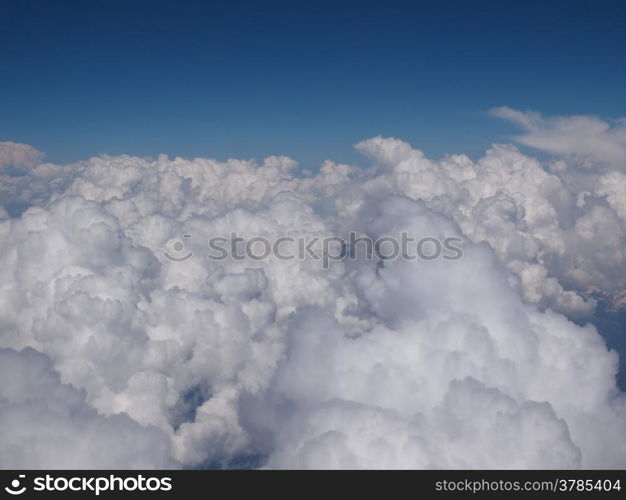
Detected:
[0,0,626,167]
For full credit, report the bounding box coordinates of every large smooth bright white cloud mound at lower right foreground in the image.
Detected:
[243,198,626,468]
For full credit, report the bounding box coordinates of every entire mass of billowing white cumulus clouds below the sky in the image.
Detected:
[0,114,626,468]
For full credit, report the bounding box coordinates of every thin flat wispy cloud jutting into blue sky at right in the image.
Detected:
[491,106,626,171]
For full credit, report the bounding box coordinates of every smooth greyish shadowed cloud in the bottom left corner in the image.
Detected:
[0,348,172,469]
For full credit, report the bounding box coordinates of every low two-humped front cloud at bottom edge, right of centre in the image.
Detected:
[268,379,581,469]
